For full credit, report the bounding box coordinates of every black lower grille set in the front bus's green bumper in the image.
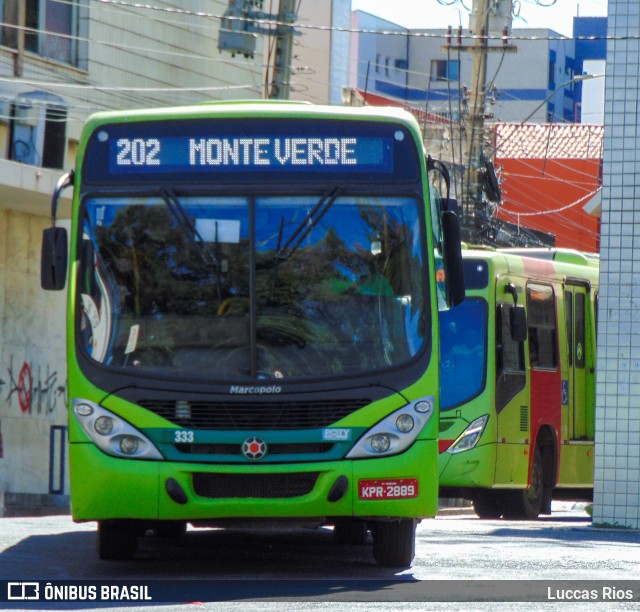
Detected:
[193,472,319,499]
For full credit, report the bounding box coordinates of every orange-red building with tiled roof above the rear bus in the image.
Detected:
[494,123,604,253]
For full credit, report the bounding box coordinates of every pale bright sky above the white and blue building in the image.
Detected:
[351,0,607,36]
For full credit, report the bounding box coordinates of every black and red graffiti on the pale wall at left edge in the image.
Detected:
[0,356,67,415]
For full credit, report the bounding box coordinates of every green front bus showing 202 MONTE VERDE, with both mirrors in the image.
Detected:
[42,102,464,566]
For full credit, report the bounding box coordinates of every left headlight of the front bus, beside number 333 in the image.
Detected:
[72,399,164,459]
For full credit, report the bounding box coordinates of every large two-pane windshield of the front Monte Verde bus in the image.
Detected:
[77,194,428,380]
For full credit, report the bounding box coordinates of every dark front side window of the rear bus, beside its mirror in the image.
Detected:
[496,304,526,412]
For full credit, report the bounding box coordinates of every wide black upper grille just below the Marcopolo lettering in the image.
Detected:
[138,398,371,431]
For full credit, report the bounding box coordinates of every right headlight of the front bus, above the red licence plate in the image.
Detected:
[347,397,434,459]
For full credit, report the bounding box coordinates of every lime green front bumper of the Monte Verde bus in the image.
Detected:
[70,440,438,521]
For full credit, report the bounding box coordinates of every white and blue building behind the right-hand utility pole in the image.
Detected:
[351,11,606,123]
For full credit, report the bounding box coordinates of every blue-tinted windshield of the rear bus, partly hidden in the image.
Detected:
[439,298,487,410]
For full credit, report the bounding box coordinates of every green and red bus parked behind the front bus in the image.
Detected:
[440,249,599,519]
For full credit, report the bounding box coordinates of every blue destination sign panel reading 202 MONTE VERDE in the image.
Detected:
[83,117,424,184]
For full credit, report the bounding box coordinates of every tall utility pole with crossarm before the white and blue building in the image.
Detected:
[444,0,516,244]
